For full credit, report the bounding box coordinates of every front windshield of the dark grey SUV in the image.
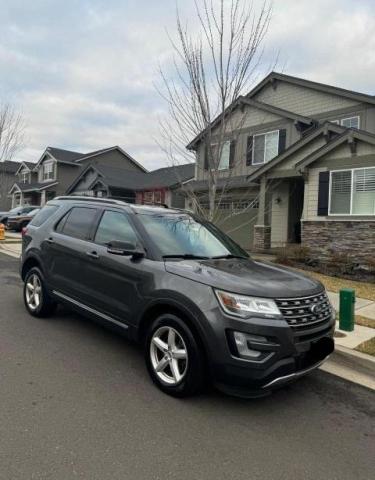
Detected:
[138,213,248,258]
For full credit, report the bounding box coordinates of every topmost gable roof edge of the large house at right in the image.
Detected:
[246,72,375,104]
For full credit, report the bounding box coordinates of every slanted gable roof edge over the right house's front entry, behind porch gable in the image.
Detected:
[247,122,348,182]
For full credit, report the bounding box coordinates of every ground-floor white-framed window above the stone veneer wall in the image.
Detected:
[329,167,375,215]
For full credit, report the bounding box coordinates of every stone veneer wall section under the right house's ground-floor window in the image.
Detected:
[302,220,375,265]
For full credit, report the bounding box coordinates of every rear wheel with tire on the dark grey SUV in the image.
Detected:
[23,267,57,318]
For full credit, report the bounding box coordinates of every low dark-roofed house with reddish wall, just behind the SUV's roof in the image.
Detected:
[66,164,195,208]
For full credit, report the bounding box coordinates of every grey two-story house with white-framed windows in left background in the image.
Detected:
[9,146,146,206]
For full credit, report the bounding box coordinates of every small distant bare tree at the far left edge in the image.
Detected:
[0,103,24,208]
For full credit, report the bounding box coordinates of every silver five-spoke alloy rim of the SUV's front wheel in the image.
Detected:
[150,326,188,385]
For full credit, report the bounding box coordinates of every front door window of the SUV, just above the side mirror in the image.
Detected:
[95,210,137,245]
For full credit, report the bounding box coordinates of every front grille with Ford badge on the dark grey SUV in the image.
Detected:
[276,292,332,329]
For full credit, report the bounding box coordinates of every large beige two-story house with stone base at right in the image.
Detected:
[188,72,375,263]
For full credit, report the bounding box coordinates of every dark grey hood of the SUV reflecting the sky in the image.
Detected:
[165,258,324,298]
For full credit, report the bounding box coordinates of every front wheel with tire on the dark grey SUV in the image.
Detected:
[145,313,205,397]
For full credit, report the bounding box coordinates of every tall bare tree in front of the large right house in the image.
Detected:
[159,0,271,221]
